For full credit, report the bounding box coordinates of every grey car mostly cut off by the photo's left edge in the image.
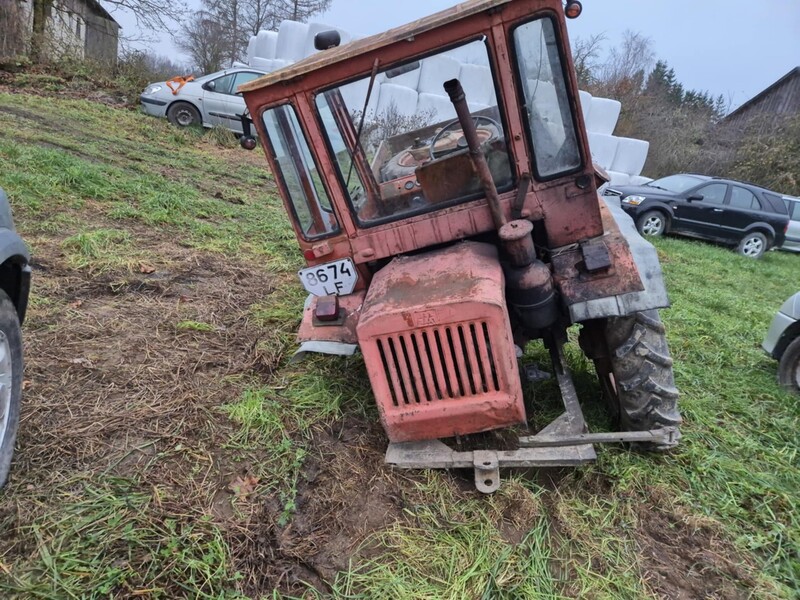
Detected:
[0,189,31,488]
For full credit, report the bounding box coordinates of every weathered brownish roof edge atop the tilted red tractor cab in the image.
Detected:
[238,0,513,92]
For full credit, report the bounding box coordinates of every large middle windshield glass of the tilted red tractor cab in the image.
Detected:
[315,39,512,225]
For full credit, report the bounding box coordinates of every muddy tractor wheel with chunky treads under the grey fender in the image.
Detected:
[587,310,681,451]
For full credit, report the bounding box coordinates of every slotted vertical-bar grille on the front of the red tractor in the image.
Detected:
[375,321,500,407]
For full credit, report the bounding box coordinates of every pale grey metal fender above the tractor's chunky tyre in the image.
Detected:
[569,198,670,323]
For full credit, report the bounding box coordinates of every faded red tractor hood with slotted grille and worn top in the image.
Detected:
[357,242,525,442]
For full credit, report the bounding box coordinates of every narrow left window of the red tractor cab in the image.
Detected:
[263,104,339,240]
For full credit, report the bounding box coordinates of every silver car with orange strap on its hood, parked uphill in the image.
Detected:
[139,67,265,133]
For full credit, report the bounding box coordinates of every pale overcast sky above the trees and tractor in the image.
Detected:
[114,0,800,107]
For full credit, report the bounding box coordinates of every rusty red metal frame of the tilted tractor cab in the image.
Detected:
[245,0,602,265]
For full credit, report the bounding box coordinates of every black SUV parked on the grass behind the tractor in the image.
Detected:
[605,174,789,258]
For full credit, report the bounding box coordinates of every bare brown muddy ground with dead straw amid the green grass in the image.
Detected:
[0,217,764,600]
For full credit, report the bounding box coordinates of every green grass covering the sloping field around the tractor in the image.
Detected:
[0,93,800,599]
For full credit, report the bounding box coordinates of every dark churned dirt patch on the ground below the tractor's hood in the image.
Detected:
[223,419,405,596]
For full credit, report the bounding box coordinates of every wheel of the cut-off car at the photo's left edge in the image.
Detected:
[0,290,22,488]
